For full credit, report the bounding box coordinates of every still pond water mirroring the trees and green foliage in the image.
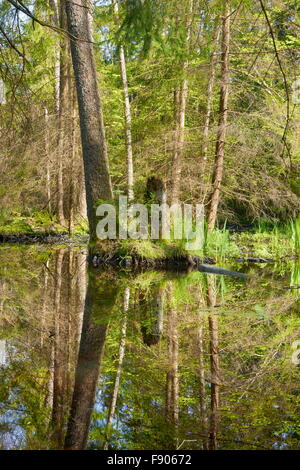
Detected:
[0,245,300,450]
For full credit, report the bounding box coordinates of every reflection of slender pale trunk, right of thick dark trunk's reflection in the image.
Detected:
[103,287,130,450]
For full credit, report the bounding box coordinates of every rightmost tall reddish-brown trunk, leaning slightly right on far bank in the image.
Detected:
[208,0,230,230]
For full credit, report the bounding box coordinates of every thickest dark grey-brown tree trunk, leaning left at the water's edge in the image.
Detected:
[66,0,112,239]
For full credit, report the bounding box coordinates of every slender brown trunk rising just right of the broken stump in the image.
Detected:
[171,0,194,204]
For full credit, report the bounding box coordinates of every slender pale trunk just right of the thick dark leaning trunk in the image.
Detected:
[113,0,134,201]
